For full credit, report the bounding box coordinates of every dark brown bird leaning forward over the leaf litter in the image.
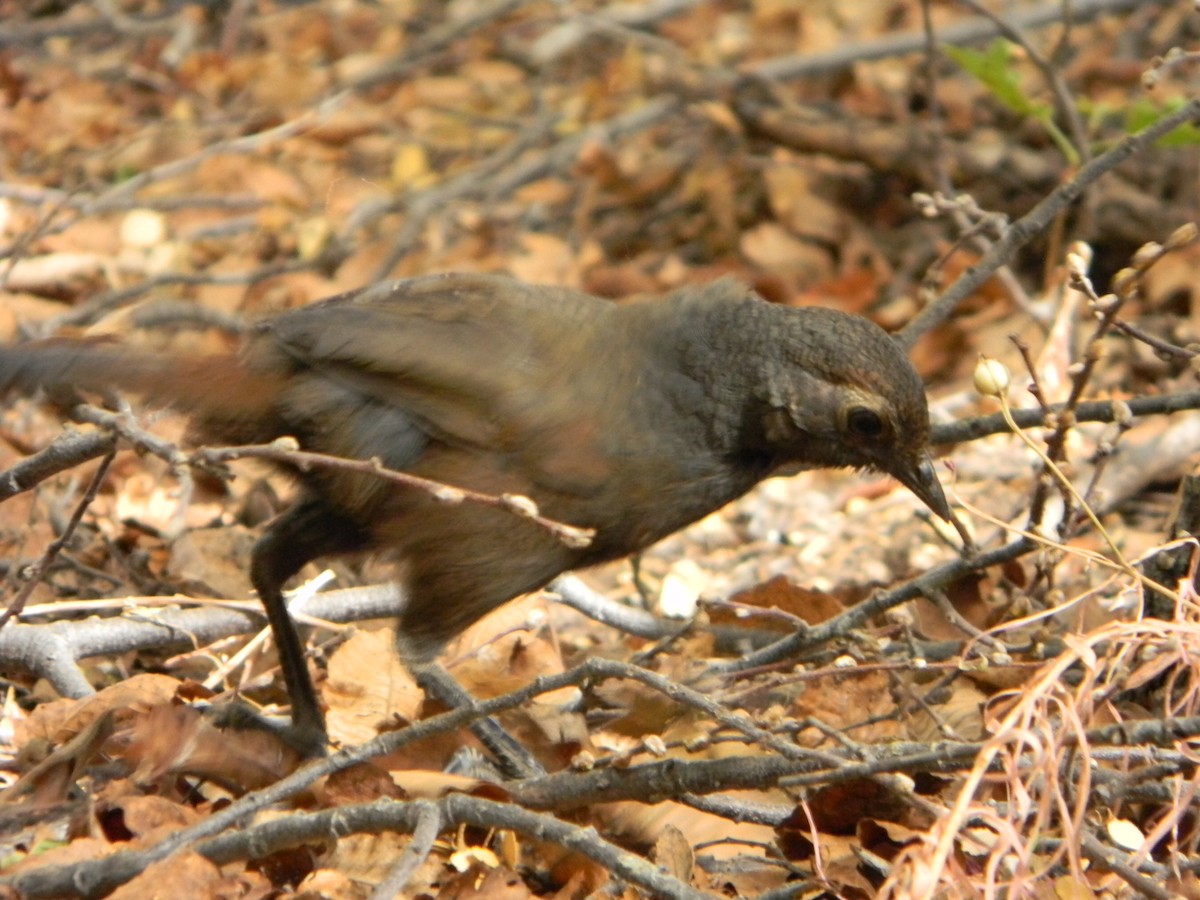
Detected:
[0,275,950,752]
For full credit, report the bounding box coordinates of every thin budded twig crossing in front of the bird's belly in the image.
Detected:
[191,442,594,547]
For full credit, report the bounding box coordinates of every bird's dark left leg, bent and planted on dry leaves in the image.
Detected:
[250,498,367,756]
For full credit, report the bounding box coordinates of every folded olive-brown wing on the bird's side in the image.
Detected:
[251,275,607,490]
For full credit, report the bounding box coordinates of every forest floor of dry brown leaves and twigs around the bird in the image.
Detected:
[0,0,1200,900]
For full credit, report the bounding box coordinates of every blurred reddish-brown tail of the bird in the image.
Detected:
[0,338,282,443]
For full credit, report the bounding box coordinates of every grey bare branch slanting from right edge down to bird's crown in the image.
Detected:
[900,98,1200,347]
